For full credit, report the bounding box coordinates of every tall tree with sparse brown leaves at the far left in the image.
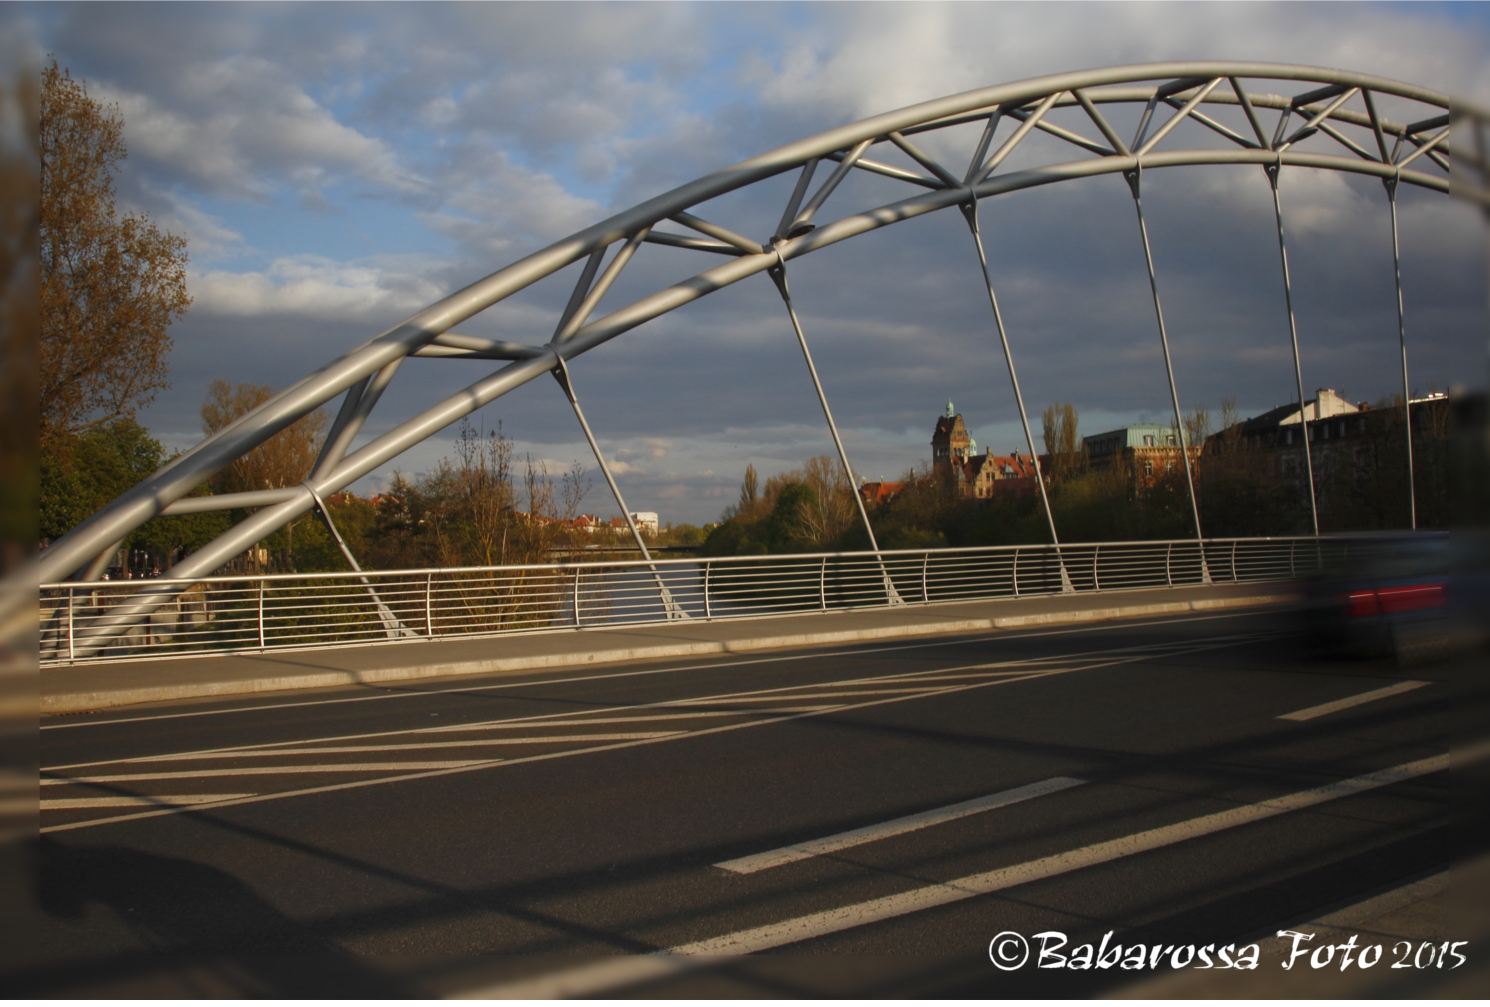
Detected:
[39,60,191,445]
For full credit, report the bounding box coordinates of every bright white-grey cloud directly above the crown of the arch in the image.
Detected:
[749,3,1490,119]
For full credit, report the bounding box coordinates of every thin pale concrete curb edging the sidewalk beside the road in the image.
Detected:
[40,594,1295,714]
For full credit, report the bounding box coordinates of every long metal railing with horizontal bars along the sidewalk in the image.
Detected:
[40,538,1394,666]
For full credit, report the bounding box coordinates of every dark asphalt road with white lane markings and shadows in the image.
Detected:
[17,612,1490,997]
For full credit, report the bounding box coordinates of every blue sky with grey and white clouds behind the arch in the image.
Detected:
[23,3,1490,523]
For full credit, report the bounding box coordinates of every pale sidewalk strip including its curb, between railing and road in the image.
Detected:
[40,584,1293,714]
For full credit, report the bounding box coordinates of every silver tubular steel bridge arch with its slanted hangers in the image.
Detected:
[32,61,1490,652]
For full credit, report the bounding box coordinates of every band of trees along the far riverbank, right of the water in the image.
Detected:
[702,399,1448,556]
